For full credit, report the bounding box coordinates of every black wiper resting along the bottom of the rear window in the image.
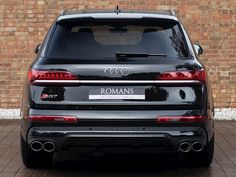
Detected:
[116,52,166,60]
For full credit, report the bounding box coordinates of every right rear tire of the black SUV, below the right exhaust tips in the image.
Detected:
[184,135,215,167]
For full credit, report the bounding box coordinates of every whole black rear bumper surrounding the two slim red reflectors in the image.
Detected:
[21,109,214,153]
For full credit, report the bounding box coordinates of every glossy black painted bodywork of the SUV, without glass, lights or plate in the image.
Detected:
[21,11,214,152]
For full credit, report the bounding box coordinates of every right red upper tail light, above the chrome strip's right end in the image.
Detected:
[156,70,206,82]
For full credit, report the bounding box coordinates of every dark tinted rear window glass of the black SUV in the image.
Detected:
[47,19,189,61]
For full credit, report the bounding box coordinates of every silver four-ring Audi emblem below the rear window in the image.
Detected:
[104,67,129,77]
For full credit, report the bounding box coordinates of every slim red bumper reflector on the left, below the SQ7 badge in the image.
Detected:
[25,116,78,123]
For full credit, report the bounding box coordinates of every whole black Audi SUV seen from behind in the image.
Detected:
[21,10,214,167]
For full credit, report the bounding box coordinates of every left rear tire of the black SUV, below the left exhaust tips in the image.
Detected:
[20,136,53,168]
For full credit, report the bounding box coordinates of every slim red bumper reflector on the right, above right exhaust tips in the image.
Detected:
[156,116,207,123]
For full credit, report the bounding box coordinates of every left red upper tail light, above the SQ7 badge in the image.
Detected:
[28,69,77,82]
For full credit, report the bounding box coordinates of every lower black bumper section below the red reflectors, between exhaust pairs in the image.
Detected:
[27,127,208,152]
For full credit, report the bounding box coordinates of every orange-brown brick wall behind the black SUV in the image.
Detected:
[0,0,236,108]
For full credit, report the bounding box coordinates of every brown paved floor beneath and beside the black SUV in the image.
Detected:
[0,120,236,177]
